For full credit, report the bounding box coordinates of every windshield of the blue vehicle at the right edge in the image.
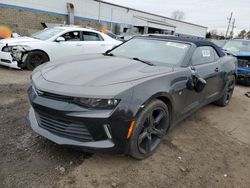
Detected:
[223,40,250,52]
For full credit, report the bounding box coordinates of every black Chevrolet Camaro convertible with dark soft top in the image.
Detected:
[28,35,236,159]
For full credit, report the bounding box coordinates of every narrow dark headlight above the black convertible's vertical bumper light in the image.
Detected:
[76,98,120,109]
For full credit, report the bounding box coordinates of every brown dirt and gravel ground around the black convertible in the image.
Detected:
[0,67,250,188]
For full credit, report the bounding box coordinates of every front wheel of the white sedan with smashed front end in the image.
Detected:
[24,51,49,70]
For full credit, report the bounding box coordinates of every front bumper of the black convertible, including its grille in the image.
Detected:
[28,88,131,154]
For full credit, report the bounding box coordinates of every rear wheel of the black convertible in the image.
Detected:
[214,75,235,107]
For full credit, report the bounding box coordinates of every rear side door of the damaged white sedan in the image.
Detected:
[82,31,107,54]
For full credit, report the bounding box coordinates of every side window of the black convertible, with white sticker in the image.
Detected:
[192,46,219,65]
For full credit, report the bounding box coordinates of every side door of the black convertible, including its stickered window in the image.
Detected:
[184,46,223,112]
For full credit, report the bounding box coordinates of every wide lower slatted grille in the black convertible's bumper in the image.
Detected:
[36,112,94,142]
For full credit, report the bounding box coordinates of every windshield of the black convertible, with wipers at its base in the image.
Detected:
[111,38,190,66]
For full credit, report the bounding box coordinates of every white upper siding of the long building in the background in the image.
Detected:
[0,0,207,37]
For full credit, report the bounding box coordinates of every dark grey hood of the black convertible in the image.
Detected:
[41,55,173,87]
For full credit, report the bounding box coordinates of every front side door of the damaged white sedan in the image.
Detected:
[51,30,84,59]
